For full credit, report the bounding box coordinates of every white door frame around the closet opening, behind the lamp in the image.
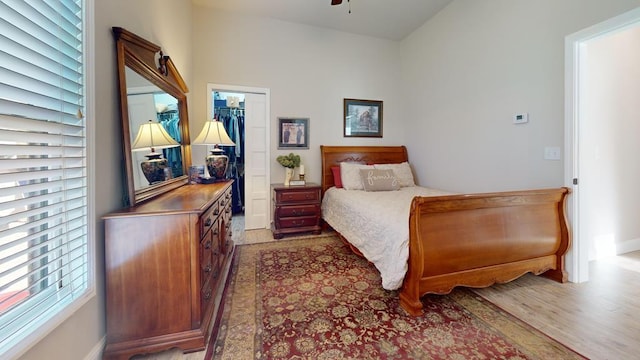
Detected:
[207,83,271,230]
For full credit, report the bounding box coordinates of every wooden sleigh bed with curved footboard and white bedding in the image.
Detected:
[320,145,571,316]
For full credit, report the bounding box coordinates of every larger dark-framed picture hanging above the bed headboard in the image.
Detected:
[344,99,382,137]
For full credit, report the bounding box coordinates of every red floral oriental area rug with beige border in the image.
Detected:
[207,235,583,360]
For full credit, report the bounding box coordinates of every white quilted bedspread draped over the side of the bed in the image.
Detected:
[322,186,451,290]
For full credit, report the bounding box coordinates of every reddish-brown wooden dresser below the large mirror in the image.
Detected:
[104,181,233,359]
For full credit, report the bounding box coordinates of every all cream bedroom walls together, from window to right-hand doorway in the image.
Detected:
[15,0,640,360]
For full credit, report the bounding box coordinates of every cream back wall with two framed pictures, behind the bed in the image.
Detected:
[190,6,405,182]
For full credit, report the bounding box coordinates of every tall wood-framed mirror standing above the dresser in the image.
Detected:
[113,27,191,206]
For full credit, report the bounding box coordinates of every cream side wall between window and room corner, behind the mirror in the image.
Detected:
[21,0,192,360]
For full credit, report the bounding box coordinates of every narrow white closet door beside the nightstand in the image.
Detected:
[244,93,271,230]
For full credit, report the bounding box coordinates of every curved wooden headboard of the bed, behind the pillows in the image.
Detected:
[320,145,409,194]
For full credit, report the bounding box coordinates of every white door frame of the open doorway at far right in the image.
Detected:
[564,4,640,283]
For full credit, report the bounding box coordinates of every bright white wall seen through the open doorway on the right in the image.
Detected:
[579,25,640,260]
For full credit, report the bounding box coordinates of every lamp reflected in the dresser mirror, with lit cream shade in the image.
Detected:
[131,120,180,185]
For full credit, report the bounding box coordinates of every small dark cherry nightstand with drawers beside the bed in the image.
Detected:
[271,183,322,239]
